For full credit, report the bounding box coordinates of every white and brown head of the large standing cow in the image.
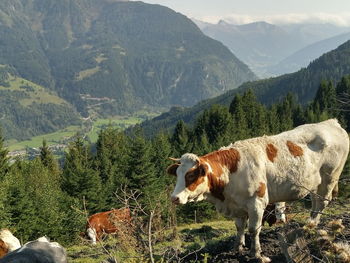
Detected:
[167,153,209,204]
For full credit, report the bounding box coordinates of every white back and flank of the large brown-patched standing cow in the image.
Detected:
[233,119,349,202]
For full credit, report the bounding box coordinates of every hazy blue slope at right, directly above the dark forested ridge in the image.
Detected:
[269,32,350,75]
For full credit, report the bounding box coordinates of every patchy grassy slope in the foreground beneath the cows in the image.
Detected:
[67,200,350,263]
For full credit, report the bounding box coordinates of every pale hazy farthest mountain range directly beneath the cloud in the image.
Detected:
[194,20,349,77]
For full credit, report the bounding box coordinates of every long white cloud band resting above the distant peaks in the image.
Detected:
[197,12,350,26]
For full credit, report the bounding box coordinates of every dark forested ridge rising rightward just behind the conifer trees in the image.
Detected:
[141,41,350,135]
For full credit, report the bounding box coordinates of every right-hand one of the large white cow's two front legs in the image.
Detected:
[248,200,271,262]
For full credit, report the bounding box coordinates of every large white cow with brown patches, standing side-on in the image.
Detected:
[168,119,349,262]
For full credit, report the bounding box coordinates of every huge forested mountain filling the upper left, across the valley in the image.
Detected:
[0,0,256,141]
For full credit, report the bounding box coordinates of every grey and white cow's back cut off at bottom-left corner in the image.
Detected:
[0,237,68,263]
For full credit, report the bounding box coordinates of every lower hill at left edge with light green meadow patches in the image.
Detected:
[0,65,80,139]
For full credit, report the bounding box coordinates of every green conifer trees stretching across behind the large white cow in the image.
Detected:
[0,76,350,244]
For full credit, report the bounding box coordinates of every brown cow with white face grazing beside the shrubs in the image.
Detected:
[85,208,131,245]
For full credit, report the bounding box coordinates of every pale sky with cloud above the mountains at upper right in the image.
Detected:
[133,0,350,26]
